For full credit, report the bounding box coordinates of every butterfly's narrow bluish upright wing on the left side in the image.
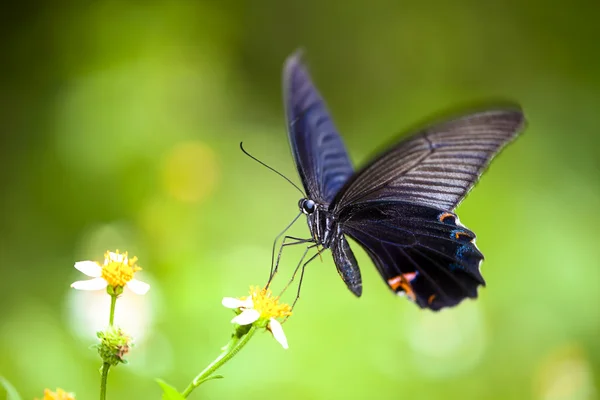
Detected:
[283,52,354,204]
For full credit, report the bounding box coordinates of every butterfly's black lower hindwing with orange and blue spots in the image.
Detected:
[341,202,485,310]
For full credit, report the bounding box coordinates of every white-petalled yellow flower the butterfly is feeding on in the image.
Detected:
[222,287,292,349]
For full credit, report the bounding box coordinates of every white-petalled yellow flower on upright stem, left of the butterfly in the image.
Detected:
[71,250,150,294]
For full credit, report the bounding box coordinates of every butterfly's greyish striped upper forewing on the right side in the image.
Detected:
[330,110,524,212]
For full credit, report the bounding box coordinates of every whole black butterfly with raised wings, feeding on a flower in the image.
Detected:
[280,53,524,310]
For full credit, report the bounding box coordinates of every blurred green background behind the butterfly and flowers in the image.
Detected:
[0,0,600,400]
